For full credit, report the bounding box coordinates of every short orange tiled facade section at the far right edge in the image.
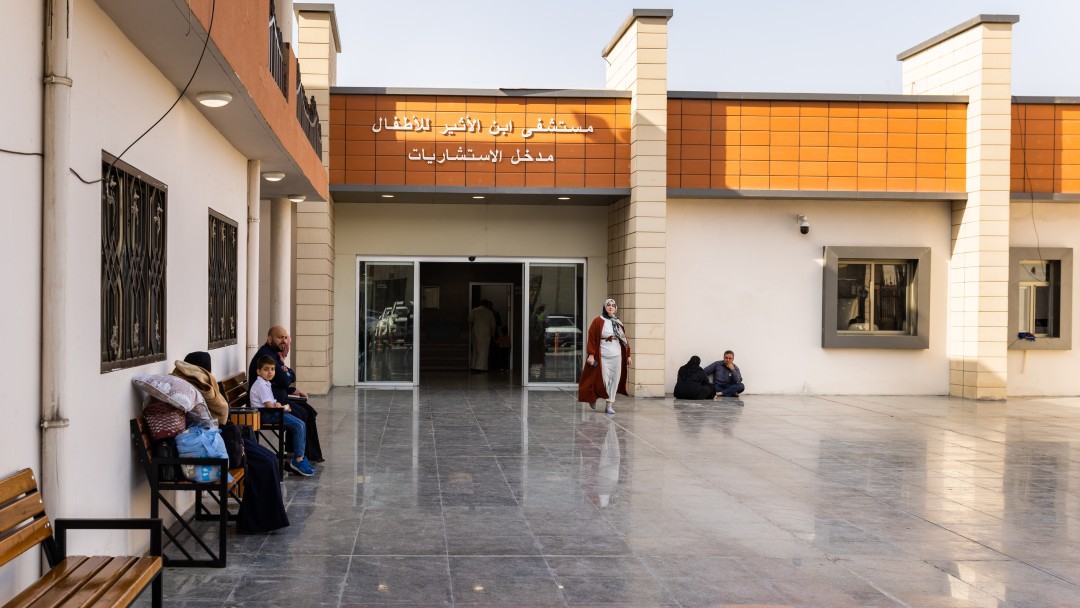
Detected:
[1011,104,1080,193]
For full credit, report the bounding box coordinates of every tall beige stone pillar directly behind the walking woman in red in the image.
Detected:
[603,9,673,396]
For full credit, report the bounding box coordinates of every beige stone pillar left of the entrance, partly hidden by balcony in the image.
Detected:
[293,2,341,394]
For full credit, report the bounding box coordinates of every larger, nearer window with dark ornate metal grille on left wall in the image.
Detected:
[102,152,168,373]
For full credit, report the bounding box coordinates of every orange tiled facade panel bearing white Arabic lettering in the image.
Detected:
[330,94,630,189]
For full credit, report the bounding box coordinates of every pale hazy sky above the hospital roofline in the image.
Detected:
[334,0,1080,97]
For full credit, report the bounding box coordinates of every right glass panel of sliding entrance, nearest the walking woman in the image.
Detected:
[522,262,585,386]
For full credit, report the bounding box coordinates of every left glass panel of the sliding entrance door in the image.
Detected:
[356,261,417,384]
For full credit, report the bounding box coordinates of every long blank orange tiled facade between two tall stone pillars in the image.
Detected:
[667,99,967,192]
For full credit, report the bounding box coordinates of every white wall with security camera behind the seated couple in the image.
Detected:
[665,199,949,394]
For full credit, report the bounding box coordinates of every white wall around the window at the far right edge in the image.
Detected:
[1009,200,1080,396]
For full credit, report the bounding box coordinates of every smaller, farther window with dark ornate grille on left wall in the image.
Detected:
[206,210,237,349]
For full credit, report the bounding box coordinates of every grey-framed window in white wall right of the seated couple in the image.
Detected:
[821,247,930,349]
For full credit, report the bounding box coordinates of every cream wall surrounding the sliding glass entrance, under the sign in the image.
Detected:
[334,203,607,386]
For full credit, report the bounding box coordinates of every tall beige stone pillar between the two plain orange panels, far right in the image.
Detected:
[897,15,1020,400]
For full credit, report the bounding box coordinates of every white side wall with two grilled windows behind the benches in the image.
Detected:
[0,1,247,565]
